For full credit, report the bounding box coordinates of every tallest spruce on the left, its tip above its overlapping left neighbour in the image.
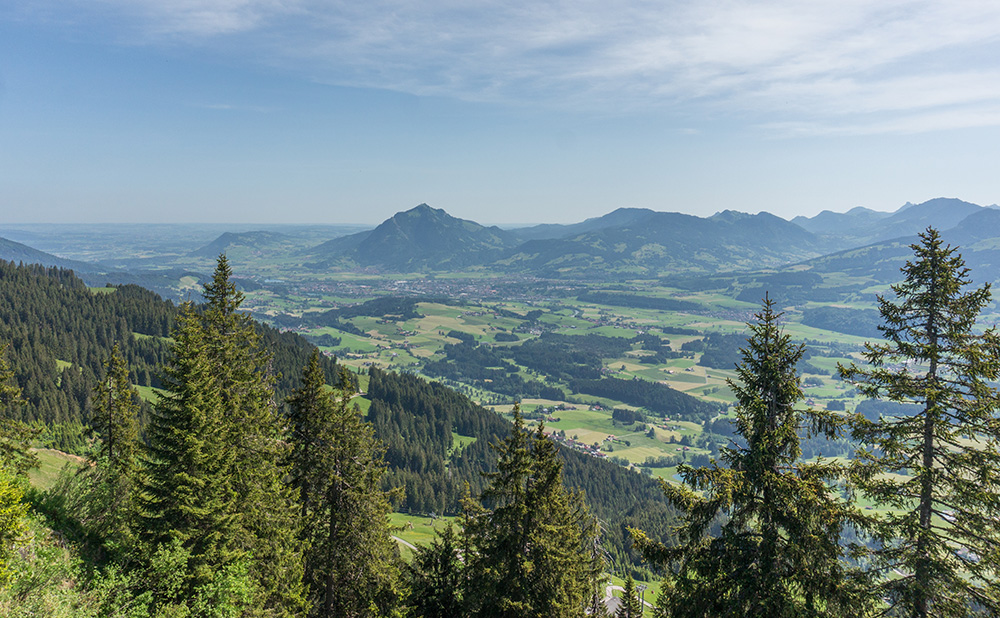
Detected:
[200,255,302,615]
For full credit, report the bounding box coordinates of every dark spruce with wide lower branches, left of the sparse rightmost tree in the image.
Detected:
[634,298,867,618]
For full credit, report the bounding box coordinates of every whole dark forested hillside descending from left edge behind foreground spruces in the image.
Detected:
[0,262,673,562]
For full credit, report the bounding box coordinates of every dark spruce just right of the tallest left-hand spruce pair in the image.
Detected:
[289,351,400,618]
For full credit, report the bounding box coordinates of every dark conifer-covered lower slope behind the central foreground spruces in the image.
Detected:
[368,369,676,564]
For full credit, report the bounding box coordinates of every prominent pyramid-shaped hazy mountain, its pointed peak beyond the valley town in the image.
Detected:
[309,204,517,272]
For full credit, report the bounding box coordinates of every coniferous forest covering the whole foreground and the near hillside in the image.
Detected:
[0,228,1000,618]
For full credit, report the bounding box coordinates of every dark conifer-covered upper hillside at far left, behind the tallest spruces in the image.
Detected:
[0,261,338,448]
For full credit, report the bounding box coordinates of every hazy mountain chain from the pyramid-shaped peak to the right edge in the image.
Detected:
[296,198,1000,278]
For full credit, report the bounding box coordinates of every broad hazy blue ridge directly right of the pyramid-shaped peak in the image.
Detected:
[500,210,822,277]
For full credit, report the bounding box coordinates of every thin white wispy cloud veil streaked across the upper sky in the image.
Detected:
[19,0,1000,134]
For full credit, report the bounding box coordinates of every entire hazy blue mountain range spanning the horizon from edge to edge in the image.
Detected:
[0,198,1000,287]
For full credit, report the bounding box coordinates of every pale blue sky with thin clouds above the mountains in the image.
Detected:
[0,0,1000,225]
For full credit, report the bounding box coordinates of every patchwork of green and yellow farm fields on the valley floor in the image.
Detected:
[262,282,871,481]
